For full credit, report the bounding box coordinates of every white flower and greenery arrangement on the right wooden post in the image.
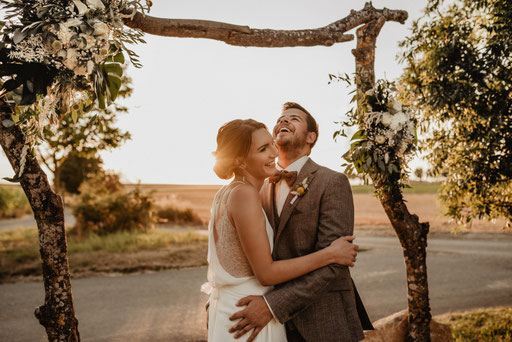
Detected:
[334,78,417,190]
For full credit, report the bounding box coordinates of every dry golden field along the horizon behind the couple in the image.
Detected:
[129,184,512,236]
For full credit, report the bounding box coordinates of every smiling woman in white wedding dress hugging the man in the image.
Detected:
[202,119,356,342]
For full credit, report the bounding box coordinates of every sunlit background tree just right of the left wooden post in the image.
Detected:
[37,76,133,193]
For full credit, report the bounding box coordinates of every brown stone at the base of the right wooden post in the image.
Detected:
[364,309,453,342]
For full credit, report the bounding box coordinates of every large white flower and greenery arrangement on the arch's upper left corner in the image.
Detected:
[0,0,151,180]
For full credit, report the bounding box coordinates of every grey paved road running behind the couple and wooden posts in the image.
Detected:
[0,236,512,342]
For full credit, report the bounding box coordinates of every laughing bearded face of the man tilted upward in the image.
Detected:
[273,108,310,149]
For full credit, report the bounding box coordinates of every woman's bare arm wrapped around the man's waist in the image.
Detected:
[228,185,357,286]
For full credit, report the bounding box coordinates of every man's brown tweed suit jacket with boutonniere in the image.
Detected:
[261,159,371,342]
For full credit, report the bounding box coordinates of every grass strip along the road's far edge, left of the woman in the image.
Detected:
[0,228,208,282]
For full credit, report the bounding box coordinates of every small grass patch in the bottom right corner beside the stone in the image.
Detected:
[436,307,512,342]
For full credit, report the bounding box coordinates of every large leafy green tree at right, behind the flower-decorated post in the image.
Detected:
[401,0,512,227]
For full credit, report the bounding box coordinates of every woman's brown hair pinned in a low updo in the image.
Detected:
[213,119,267,179]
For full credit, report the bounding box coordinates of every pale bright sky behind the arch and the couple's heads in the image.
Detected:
[0,0,427,184]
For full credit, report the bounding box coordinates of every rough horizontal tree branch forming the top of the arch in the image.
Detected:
[125,2,408,47]
